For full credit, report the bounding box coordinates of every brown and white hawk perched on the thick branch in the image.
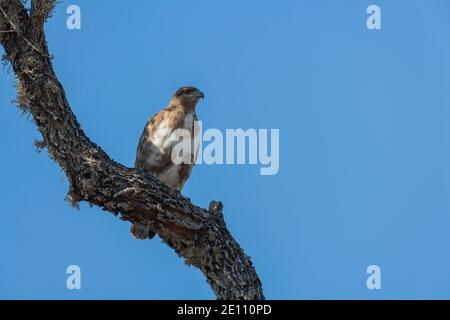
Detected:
[131,87,204,239]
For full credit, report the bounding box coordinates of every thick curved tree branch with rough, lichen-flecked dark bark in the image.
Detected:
[0,0,264,299]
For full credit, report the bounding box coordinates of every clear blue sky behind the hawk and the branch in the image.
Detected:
[0,0,450,299]
